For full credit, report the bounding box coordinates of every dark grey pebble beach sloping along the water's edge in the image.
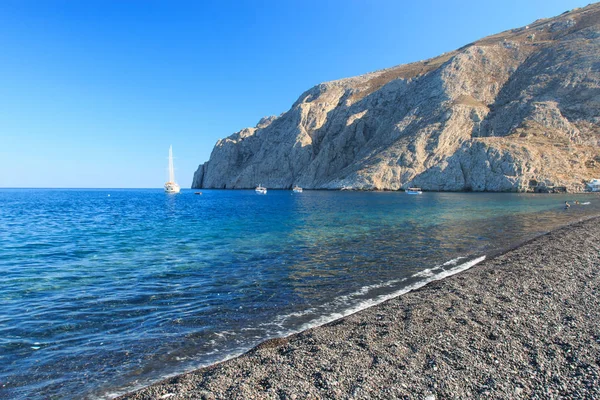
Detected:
[118,217,600,399]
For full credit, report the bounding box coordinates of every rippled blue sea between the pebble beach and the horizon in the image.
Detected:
[0,189,600,399]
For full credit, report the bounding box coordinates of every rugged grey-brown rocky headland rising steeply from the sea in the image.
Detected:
[192,3,600,191]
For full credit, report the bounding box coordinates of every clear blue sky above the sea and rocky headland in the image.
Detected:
[0,0,589,188]
